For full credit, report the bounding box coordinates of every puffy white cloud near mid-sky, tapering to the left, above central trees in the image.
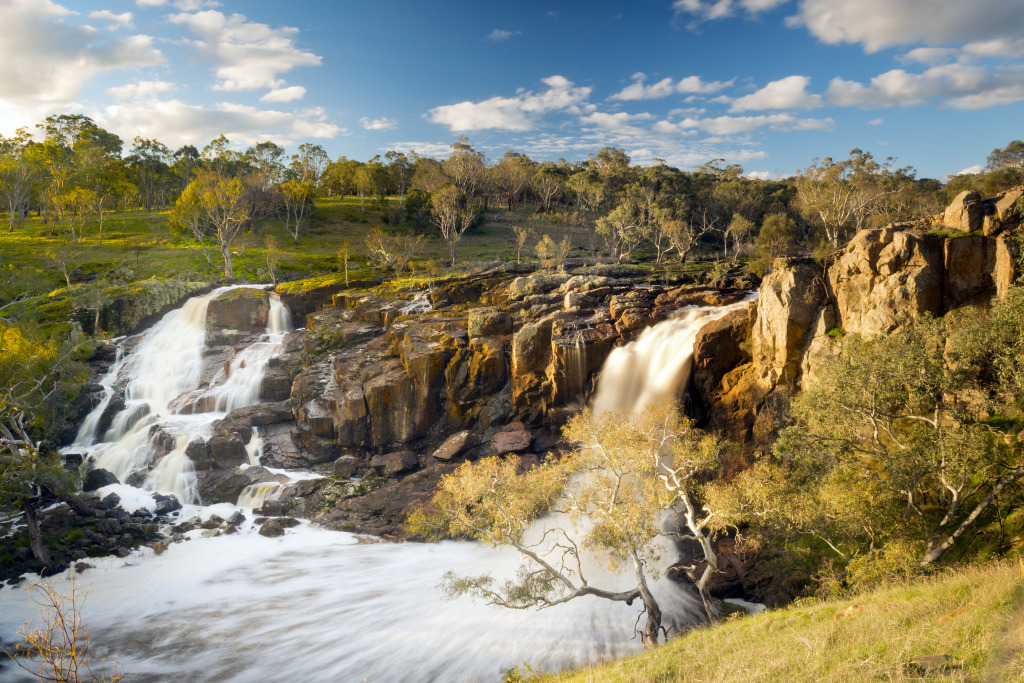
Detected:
[427,76,591,132]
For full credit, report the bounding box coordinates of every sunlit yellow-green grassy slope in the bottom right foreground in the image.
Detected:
[549,560,1024,683]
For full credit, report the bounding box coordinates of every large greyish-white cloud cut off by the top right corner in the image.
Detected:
[791,0,1024,52]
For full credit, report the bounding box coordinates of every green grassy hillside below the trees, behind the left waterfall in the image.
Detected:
[0,197,606,292]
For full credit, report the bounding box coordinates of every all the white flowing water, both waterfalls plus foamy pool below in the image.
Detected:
[0,288,745,682]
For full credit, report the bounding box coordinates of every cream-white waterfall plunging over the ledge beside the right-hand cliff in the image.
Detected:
[593,299,750,414]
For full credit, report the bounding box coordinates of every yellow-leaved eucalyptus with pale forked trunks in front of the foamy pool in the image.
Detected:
[410,403,721,647]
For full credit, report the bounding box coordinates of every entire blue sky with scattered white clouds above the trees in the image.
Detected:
[0,0,1024,177]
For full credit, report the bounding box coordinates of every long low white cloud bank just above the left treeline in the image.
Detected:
[95,98,344,148]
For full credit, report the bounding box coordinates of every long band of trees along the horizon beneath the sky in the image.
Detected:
[0,115,1024,276]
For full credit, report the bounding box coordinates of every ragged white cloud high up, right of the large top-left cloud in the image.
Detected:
[168,9,321,91]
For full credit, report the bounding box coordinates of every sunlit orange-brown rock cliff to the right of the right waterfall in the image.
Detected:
[694,189,1022,452]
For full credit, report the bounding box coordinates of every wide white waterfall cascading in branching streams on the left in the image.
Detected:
[75,287,292,503]
